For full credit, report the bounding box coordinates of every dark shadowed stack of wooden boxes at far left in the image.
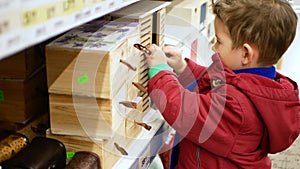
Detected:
[0,46,49,131]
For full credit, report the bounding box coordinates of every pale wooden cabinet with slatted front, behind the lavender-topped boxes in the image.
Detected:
[109,0,170,111]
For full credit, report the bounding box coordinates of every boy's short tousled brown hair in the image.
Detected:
[212,0,297,66]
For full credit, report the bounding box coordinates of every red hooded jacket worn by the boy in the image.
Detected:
[148,54,300,169]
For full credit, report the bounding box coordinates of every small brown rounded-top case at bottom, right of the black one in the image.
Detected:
[66,151,101,169]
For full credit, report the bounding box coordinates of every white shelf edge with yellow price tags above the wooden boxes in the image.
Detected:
[0,0,139,60]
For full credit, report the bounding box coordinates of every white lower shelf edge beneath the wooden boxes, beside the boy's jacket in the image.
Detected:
[113,109,172,169]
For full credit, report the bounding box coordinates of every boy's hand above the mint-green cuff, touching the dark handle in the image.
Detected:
[146,44,167,68]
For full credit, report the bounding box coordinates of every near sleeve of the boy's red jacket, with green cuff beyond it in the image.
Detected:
[148,71,242,156]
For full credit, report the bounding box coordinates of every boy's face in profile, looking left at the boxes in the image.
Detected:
[213,17,243,70]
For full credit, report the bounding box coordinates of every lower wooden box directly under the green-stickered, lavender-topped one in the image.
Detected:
[50,88,146,138]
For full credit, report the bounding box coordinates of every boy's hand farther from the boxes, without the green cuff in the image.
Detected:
[163,46,187,75]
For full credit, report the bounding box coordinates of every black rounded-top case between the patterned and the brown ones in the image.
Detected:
[2,137,66,169]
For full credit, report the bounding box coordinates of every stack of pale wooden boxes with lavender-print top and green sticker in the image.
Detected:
[46,20,155,168]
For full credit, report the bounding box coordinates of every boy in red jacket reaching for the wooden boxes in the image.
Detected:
[146,0,300,169]
